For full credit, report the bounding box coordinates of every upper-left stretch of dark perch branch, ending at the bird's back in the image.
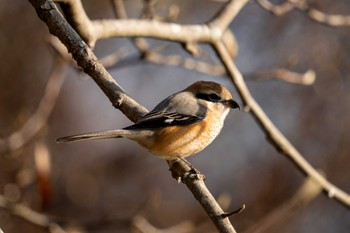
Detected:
[29,0,148,122]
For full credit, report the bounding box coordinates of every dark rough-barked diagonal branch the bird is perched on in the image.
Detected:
[26,0,235,232]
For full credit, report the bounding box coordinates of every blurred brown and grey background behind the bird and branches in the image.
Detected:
[0,0,350,233]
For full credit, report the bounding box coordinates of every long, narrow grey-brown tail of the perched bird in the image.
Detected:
[56,129,129,143]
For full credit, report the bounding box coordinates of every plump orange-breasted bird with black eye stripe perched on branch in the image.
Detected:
[57,81,240,160]
